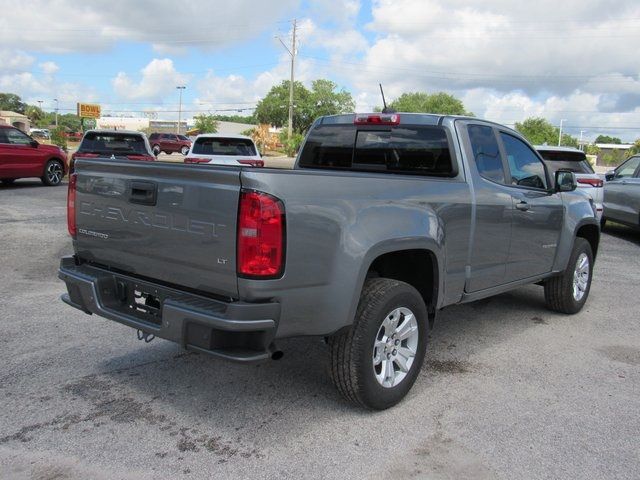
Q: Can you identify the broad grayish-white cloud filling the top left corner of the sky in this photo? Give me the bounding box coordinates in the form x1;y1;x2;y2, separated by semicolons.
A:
0;0;298;53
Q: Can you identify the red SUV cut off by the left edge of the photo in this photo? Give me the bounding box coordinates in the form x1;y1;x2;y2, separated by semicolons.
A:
0;125;67;186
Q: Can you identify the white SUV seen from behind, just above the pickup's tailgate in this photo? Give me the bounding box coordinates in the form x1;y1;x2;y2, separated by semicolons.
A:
184;133;264;167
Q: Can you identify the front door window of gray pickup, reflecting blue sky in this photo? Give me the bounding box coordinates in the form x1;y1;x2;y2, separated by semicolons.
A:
500;132;547;190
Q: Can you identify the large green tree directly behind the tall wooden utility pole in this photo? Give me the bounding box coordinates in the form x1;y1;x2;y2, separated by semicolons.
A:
254;79;355;133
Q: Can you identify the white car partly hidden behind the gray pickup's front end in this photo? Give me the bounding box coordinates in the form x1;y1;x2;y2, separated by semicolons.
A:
536;145;604;220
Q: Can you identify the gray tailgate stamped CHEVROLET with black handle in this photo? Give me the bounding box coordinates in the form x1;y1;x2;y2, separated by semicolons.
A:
75;159;240;297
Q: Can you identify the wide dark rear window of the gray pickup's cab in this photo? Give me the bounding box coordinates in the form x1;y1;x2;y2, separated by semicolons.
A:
299;124;455;176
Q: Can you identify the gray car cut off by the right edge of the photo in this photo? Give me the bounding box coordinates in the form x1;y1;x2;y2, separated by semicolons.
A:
602;155;640;228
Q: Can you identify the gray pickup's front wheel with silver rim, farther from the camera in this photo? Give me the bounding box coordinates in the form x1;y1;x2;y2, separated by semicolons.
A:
544;237;593;314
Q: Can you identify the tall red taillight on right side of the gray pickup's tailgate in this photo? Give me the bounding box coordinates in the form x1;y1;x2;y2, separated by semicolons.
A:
238;190;285;279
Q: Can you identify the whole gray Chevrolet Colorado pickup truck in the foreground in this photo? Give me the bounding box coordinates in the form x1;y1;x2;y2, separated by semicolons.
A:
59;113;600;409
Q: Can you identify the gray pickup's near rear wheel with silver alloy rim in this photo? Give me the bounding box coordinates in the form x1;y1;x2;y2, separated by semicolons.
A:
329;278;429;410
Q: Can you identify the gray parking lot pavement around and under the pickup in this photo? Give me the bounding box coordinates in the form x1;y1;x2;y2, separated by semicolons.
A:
0;180;640;479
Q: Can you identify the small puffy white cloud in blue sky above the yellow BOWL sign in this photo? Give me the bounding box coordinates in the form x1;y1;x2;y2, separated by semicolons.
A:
112;58;189;100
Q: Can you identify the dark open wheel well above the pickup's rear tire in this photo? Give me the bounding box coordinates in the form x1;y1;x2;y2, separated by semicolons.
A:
367;250;438;321
